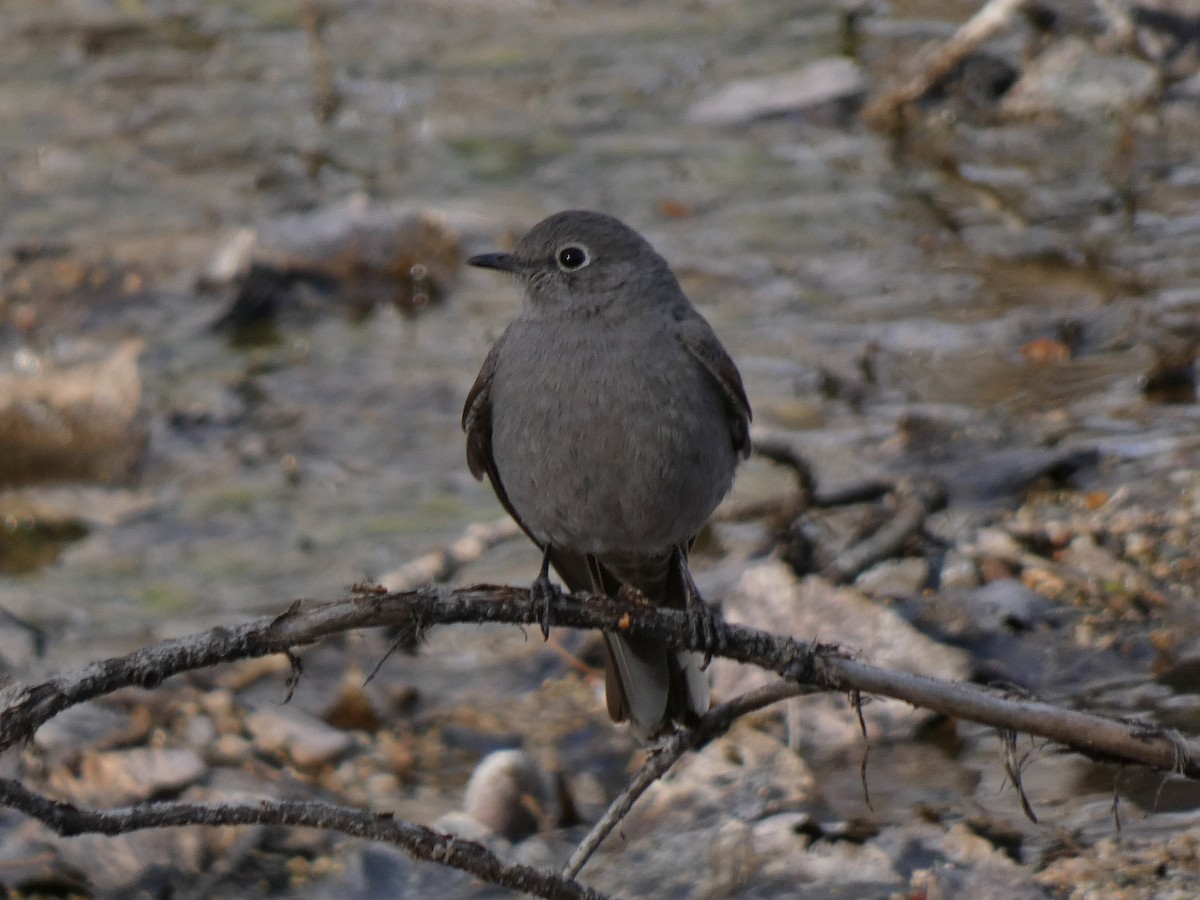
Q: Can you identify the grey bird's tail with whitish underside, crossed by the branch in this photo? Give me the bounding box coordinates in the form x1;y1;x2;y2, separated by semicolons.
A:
551;550;708;739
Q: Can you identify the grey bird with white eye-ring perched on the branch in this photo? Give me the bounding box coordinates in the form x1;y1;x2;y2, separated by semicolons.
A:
462;210;750;738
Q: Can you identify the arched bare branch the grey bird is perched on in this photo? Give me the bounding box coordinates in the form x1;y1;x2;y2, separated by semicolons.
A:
0;586;1200;778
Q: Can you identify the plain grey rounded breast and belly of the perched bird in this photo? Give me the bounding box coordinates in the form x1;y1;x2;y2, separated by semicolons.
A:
492;320;737;556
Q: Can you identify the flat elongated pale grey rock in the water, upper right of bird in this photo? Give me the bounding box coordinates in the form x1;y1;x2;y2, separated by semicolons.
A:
688;56;868;125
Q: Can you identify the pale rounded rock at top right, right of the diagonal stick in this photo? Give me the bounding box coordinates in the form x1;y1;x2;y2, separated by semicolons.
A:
1000;38;1159;118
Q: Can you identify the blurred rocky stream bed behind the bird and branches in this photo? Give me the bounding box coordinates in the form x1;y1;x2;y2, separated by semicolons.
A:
0;0;1200;896
